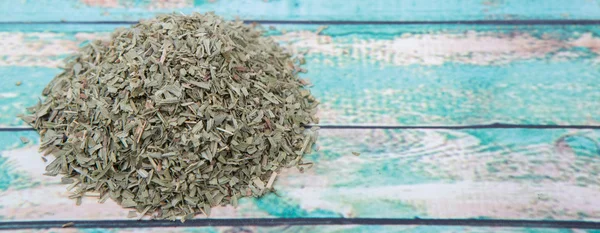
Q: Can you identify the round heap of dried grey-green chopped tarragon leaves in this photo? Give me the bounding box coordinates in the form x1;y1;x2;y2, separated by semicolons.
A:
23;13;318;220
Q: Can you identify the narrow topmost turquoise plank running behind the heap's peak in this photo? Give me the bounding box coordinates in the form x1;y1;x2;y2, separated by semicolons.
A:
0;0;600;22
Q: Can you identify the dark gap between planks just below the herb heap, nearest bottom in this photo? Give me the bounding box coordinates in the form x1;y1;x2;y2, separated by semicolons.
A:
0;218;600;230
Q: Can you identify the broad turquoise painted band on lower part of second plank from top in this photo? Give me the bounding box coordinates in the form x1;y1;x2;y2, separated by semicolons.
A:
0;58;600;126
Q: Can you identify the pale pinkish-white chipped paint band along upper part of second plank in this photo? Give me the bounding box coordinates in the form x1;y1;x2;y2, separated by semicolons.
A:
0;31;600;67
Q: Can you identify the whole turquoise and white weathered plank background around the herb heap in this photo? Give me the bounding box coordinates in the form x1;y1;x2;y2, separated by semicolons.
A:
0;0;600;232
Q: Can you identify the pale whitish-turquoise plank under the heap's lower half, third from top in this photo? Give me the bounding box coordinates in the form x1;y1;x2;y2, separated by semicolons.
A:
0;129;600;221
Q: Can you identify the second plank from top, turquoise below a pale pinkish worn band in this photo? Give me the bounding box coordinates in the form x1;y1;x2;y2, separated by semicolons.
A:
0;25;600;125
